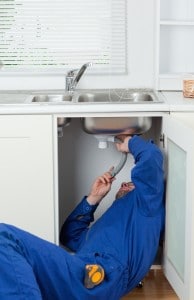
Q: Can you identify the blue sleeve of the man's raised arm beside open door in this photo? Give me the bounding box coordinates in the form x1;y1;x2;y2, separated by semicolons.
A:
128;136;164;216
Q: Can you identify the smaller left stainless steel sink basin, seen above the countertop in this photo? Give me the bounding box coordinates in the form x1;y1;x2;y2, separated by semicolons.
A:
32;94;72;104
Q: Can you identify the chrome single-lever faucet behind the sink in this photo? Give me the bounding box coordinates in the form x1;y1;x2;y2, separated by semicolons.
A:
66;62;92;92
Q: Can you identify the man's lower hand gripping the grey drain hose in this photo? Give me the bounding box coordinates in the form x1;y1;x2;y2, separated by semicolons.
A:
87;169;115;205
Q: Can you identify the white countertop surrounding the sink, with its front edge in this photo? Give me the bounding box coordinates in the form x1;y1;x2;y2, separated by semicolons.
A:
0;91;194;116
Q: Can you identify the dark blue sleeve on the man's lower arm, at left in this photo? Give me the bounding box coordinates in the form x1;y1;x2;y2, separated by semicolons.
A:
60;196;98;252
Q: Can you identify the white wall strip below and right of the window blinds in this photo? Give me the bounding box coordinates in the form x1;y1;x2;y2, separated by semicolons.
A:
0;0;156;90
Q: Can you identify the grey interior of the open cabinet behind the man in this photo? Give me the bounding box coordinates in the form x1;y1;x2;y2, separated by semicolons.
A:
58;117;162;264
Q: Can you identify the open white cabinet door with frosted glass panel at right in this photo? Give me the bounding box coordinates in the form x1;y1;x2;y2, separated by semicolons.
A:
163;113;194;300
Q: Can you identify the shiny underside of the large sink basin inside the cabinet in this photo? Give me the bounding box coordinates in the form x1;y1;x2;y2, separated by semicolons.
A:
81;116;152;135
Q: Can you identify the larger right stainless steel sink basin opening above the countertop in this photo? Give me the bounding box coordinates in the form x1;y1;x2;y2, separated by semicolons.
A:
77;89;162;104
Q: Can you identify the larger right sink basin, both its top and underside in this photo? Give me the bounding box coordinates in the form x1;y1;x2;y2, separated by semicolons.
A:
77;89;163;135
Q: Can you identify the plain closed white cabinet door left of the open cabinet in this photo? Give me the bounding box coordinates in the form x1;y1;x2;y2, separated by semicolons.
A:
0;115;55;242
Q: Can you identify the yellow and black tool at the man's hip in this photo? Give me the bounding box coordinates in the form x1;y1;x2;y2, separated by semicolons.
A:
84;265;104;289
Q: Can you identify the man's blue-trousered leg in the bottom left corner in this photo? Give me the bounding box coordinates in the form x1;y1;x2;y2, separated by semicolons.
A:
0;226;42;300
